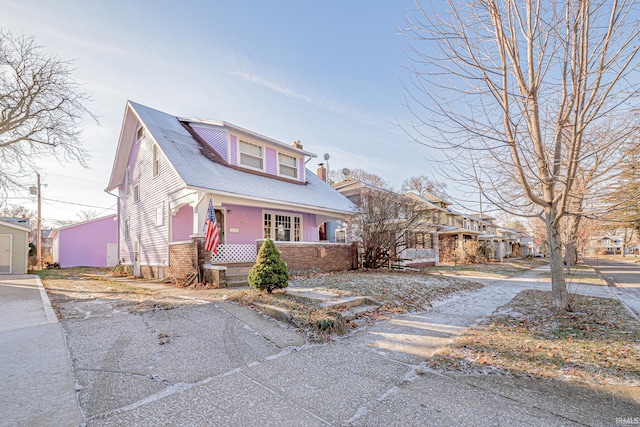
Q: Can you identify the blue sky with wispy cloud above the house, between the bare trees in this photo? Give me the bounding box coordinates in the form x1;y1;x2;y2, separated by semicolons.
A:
0;0;451;225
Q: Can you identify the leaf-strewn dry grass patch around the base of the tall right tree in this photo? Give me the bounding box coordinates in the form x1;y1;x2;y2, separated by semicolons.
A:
428;290;640;385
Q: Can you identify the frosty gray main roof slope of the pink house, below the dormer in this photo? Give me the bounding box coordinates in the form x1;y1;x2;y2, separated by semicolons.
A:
129;101;355;213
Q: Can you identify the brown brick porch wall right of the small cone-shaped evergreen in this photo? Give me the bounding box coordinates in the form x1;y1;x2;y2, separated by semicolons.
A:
257;241;358;275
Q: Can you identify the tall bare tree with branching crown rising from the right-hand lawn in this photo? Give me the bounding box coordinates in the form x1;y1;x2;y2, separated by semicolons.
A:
405;0;640;310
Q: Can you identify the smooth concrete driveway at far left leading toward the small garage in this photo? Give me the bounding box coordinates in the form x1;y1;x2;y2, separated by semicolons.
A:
0;275;82;426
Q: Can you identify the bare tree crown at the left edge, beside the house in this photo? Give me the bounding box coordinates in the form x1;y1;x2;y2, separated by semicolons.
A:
0;30;95;195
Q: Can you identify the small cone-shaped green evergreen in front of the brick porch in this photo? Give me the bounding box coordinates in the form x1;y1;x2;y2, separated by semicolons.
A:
249;239;289;293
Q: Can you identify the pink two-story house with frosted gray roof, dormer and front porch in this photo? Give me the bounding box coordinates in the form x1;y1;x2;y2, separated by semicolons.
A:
107;102;354;277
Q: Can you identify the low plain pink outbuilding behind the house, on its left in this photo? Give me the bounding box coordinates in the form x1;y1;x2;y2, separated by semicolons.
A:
50;215;118;267
